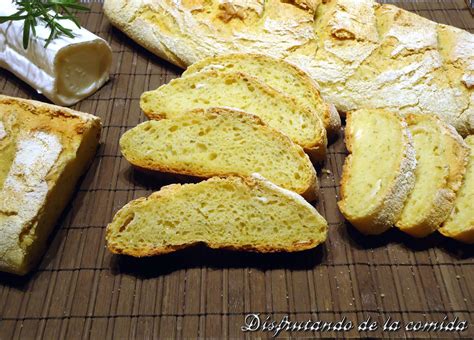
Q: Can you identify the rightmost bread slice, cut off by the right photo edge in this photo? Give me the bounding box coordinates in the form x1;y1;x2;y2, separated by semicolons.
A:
438;135;474;244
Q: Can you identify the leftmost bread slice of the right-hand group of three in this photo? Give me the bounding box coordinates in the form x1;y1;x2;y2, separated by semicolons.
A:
338;110;416;235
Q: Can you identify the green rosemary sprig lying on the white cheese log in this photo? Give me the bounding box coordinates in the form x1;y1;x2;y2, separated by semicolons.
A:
0;0;89;50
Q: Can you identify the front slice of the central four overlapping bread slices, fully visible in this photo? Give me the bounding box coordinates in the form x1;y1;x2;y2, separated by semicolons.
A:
106;176;327;257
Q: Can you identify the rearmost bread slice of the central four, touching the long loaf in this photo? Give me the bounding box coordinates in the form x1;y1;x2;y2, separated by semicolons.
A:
183;53;341;135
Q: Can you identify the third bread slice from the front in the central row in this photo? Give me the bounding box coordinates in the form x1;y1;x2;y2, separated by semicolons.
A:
140;71;327;159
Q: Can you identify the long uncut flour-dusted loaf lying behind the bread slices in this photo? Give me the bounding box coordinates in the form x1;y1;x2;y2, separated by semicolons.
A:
104;0;474;135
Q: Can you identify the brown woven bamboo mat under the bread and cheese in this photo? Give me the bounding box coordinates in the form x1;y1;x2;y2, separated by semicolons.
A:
0;0;474;339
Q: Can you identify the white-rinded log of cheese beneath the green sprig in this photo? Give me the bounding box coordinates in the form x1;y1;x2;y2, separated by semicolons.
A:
0;0;112;106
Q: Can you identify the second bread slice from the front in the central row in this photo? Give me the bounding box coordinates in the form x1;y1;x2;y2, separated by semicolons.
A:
120;108;318;200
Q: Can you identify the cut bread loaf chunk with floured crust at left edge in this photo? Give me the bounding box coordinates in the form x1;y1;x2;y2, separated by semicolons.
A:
0;96;101;275
